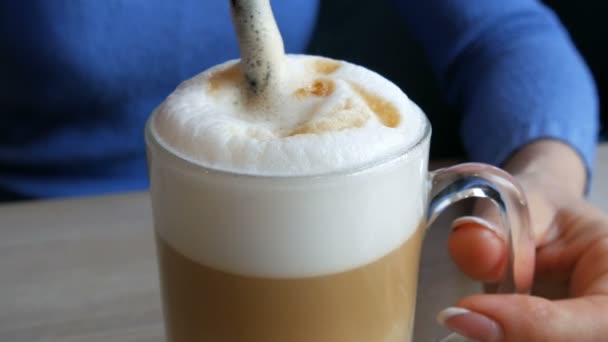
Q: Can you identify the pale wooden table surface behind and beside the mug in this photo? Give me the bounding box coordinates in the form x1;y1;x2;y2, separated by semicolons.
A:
0;145;608;342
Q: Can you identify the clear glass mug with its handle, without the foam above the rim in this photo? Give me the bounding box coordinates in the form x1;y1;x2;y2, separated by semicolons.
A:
146;115;534;342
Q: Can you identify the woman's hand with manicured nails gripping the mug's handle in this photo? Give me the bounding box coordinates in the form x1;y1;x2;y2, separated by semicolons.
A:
438;140;608;342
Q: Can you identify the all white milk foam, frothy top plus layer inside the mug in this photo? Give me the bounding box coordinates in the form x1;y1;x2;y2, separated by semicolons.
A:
149;55;428;278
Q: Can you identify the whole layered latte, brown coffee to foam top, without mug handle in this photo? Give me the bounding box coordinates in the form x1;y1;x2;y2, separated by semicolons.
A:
147;55;429;342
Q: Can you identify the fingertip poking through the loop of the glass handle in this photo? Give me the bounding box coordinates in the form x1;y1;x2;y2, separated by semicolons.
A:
448;217;507;283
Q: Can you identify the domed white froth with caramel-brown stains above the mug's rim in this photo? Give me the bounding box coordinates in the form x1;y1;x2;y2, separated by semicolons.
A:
151;55;425;176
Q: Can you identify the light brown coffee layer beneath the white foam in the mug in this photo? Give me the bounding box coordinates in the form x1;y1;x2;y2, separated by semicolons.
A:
158;227;423;342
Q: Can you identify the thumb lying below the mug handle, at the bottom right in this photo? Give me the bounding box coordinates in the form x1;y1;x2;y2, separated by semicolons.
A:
437;295;608;342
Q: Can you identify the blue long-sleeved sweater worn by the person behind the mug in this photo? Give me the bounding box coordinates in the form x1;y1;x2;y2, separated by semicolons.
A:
0;0;598;197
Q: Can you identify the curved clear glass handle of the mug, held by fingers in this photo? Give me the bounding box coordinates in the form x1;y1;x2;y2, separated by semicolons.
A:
427;163;535;341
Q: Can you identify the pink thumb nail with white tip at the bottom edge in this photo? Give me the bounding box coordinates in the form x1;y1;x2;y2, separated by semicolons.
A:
437;307;503;342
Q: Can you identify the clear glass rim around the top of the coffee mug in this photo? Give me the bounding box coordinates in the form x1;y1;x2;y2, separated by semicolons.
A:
144;110;432;180
